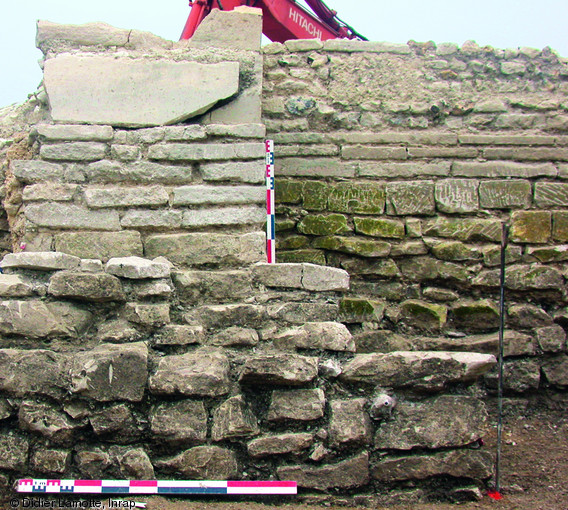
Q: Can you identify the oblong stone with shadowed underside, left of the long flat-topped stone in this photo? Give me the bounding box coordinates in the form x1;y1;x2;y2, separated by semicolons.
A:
239;353;318;386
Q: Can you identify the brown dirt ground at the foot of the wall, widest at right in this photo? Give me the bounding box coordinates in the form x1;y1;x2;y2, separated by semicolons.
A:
6;396;568;510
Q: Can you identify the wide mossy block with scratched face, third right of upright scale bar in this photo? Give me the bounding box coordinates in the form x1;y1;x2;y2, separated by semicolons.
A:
327;183;385;214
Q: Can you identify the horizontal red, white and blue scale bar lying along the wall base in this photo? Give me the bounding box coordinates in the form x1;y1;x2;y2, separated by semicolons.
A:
17;478;298;495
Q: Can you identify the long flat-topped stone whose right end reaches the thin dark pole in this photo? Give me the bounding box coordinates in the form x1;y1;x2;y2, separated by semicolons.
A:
340;351;496;390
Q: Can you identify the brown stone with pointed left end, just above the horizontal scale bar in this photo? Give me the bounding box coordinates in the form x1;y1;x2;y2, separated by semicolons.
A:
154;446;238;480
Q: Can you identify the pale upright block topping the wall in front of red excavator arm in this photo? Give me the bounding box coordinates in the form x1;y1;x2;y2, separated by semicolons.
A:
188;6;262;51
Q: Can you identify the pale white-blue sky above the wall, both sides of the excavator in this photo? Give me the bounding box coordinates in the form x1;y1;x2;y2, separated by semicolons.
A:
0;0;568;107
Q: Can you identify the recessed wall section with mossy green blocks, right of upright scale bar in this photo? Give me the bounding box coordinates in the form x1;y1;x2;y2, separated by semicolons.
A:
263;41;568;396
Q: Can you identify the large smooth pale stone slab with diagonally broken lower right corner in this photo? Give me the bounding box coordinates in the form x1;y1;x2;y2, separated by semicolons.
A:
44;55;239;127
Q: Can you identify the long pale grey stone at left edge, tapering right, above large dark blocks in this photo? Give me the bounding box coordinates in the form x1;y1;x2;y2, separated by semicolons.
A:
0;301;91;338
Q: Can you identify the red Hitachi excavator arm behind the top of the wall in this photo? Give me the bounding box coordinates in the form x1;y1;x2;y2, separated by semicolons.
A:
181;0;367;42
